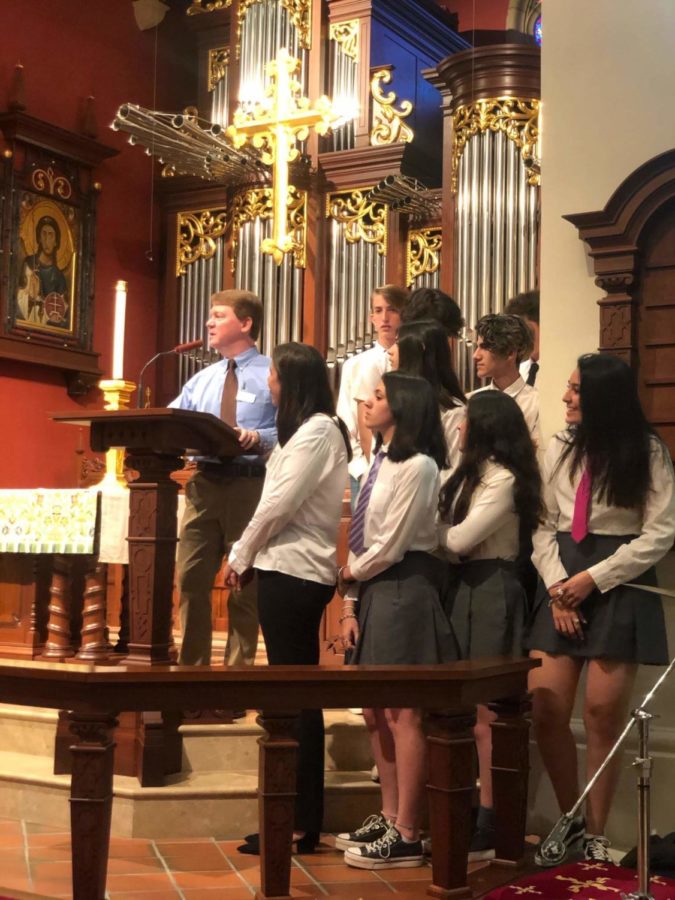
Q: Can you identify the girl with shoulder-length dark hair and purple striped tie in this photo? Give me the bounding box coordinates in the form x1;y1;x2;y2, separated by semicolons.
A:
336;372;457;869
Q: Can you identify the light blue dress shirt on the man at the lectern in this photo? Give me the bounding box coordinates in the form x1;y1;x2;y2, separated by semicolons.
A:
169;347;277;465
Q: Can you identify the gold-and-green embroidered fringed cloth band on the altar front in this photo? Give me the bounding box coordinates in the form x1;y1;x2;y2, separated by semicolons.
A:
0;489;99;554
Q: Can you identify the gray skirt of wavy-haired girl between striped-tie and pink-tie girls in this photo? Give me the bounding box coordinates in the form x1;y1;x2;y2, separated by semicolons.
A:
445;559;526;659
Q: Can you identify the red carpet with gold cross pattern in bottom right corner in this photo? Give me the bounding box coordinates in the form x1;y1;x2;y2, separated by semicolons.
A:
485;862;675;900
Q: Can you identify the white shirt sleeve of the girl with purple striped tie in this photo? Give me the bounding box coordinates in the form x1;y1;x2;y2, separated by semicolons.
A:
349;453;439;581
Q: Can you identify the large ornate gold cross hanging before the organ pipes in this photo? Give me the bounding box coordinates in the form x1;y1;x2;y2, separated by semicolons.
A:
227;49;344;265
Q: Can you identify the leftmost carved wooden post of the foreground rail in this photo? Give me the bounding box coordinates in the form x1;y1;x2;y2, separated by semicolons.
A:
70;713;117;900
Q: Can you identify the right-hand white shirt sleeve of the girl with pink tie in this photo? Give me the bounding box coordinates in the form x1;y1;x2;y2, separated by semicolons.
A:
588;443;675;594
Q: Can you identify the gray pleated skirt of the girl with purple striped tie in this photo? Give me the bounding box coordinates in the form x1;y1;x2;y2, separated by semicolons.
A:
350;551;458;665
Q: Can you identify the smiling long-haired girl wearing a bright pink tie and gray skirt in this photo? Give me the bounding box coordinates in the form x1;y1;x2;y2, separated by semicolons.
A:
527;353;675;866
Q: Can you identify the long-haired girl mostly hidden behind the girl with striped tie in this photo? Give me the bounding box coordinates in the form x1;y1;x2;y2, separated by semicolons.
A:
389;319;466;472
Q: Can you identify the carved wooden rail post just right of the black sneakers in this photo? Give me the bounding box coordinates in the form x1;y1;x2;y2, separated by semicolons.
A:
427;713;476;898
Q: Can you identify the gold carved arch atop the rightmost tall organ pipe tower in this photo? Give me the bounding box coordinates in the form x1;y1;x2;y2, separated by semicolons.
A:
451;97;541;193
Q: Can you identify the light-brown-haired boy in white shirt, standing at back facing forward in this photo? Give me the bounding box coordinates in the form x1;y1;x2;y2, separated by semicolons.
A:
337;284;409;509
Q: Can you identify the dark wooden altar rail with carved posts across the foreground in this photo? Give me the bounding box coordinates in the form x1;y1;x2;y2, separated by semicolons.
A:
0;658;537;900
